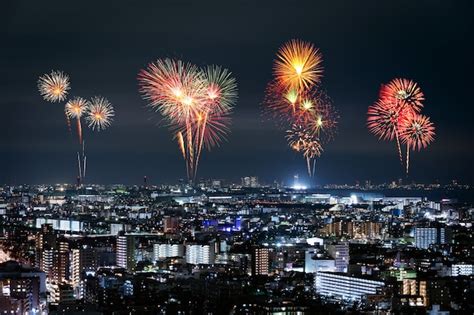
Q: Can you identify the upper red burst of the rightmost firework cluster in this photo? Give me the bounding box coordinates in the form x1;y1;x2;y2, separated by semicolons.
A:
380;79;425;113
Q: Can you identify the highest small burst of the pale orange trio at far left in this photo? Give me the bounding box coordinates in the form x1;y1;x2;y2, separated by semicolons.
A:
38;71;70;102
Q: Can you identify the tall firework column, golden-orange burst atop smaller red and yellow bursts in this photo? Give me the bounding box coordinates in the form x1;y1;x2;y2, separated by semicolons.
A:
263;40;338;177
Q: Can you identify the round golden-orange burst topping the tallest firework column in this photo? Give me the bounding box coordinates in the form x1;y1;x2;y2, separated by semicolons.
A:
274;39;323;91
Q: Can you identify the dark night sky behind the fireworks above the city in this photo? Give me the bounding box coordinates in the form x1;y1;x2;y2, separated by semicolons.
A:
0;0;474;184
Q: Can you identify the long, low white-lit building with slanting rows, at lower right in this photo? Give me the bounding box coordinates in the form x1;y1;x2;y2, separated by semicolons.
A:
315;272;385;301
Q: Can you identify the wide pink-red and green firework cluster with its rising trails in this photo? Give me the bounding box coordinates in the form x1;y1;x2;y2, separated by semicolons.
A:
138;59;237;181
